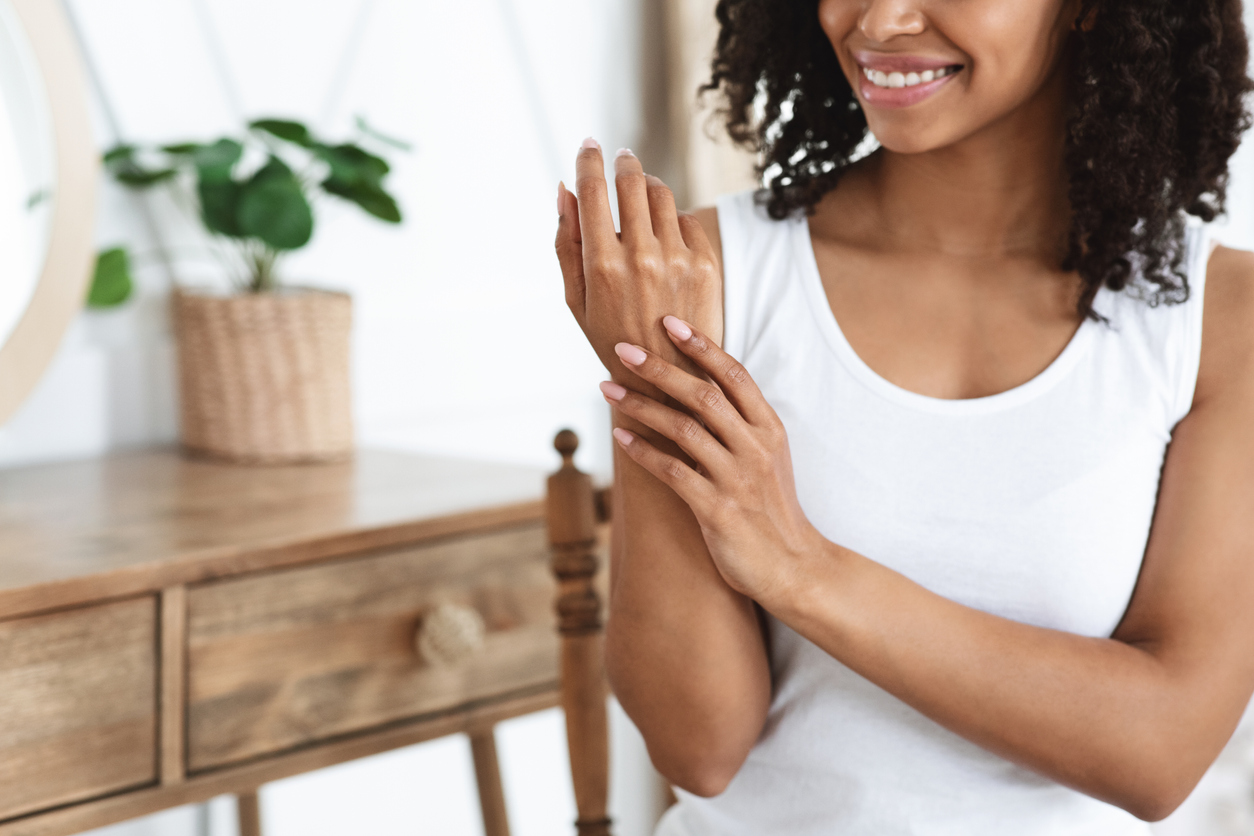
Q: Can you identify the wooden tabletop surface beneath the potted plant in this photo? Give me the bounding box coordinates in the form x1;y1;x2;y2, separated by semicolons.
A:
0;450;544;618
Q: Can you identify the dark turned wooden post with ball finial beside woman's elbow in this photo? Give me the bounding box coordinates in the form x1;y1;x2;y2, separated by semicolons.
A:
547;430;611;836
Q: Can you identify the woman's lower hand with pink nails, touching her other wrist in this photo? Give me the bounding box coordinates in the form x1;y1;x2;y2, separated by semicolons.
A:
601;316;825;605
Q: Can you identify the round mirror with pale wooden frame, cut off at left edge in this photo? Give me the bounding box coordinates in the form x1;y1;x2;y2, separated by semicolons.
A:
0;0;98;421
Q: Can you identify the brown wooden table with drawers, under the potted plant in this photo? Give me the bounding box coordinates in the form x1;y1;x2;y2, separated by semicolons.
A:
0;451;581;836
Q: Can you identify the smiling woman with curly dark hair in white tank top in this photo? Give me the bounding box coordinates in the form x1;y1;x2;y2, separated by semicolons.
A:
557;0;1254;836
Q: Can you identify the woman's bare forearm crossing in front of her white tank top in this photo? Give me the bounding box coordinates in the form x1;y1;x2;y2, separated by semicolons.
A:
761;541;1231;818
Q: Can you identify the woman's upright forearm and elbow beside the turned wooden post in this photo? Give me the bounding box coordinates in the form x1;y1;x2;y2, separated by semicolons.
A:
606;431;770;796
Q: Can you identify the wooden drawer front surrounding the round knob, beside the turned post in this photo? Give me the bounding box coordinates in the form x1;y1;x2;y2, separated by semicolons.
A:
187;523;558;771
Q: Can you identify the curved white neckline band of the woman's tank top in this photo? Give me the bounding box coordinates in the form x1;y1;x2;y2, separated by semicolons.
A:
794;217;1097;415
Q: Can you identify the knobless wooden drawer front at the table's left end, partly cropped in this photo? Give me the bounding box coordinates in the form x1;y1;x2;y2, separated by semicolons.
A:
0;598;157;820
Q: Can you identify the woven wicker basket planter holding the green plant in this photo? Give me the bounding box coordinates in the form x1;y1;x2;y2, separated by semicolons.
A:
173;288;352;464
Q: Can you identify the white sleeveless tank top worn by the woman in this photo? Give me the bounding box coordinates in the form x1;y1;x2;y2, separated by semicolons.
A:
657;192;1209;836
